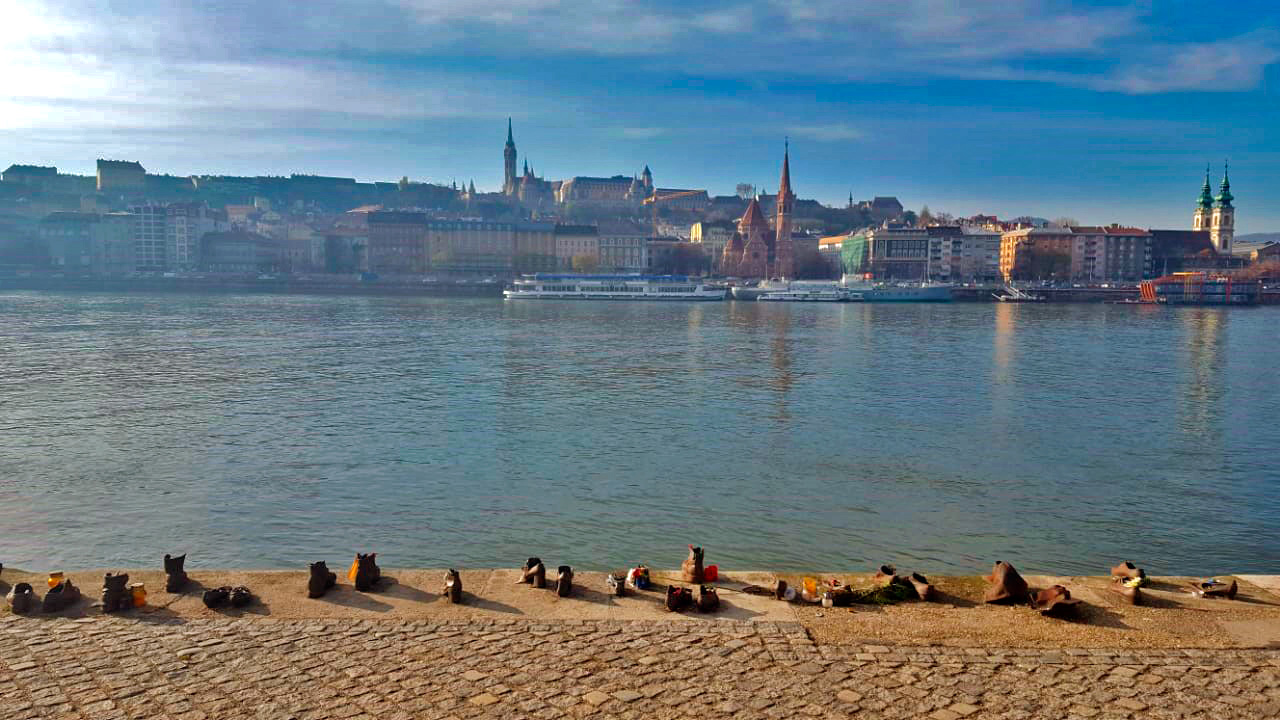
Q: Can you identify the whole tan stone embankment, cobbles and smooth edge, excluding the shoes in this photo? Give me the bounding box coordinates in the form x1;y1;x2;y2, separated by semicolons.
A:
0;568;1280;720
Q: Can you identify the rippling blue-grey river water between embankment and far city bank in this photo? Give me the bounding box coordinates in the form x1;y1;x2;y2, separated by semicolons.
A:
0;292;1280;574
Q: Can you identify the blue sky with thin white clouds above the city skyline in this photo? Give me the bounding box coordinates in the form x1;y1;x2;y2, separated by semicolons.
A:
0;0;1280;233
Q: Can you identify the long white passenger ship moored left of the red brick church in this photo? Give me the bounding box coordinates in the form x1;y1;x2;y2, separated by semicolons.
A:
502;273;724;300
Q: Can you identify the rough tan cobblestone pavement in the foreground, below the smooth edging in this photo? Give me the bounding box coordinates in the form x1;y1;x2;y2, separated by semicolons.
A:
0;616;1280;720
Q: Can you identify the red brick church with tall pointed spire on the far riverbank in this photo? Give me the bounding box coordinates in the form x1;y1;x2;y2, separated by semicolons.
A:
721;146;796;278
